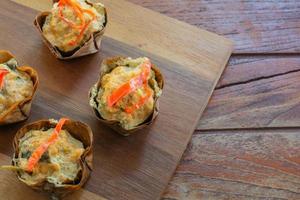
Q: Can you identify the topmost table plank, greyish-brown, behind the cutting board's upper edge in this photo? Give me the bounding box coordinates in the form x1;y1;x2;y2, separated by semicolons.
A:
130;0;300;53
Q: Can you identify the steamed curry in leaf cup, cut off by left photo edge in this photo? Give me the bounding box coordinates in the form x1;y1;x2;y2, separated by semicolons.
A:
0;50;39;125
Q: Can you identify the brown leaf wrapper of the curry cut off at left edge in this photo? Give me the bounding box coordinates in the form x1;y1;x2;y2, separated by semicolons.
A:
0;50;39;125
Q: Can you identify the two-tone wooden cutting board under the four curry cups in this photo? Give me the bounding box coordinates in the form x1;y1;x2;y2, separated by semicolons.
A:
0;0;233;200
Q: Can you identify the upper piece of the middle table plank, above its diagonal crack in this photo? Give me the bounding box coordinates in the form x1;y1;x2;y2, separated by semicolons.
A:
216;55;300;89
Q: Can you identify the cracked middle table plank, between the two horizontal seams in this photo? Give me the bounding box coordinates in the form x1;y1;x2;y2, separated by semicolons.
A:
198;56;300;129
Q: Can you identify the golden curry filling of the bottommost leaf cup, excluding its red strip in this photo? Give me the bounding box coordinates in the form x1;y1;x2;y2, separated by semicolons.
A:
15;122;84;185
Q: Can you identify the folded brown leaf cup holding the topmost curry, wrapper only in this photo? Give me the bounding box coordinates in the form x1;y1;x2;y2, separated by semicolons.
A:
34;0;107;60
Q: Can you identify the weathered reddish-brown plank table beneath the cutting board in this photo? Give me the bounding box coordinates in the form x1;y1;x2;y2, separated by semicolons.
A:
126;0;300;200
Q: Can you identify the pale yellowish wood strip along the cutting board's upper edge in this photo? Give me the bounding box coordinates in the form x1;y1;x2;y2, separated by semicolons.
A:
12;0;233;79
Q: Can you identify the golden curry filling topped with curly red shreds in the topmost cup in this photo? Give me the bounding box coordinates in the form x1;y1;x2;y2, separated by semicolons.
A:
43;0;106;52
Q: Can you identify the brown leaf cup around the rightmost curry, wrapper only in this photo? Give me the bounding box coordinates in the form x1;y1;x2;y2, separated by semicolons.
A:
89;57;164;136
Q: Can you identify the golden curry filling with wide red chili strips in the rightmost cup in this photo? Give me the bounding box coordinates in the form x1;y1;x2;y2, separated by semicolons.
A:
96;57;161;130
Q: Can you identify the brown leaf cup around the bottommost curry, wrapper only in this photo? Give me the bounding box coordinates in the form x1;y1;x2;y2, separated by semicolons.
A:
12;120;93;199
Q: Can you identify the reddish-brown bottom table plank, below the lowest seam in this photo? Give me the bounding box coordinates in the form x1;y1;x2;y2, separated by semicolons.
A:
163;129;300;200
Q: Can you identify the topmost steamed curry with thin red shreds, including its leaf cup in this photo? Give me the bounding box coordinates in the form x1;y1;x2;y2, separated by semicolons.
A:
34;0;107;60
